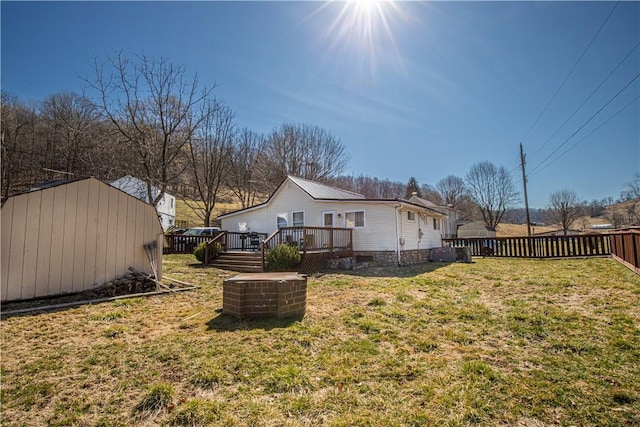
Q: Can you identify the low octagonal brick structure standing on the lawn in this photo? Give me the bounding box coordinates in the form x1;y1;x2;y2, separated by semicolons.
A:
222;273;307;319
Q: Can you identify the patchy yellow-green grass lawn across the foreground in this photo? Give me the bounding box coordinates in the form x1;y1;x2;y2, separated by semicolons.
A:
1;255;640;426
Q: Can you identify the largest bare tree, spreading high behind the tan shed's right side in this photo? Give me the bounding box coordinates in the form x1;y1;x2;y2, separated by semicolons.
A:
86;52;213;210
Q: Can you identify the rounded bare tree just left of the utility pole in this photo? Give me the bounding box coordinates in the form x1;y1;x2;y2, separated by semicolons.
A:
465;161;518;227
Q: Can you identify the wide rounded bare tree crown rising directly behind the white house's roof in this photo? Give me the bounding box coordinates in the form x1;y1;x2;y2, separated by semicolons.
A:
264;124;349;185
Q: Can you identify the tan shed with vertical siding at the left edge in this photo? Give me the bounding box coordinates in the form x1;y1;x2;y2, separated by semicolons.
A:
0;178;163;302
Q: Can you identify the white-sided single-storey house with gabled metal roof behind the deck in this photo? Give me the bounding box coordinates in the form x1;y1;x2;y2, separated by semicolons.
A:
218;176;446;265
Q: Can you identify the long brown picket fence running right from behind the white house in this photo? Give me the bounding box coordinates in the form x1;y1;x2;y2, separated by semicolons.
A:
442;234;611;258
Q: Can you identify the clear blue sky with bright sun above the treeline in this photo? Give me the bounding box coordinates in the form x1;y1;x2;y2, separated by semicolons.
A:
1;1;640;207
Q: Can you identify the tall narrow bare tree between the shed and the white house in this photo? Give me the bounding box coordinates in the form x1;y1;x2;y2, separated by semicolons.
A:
184;100;235;227
